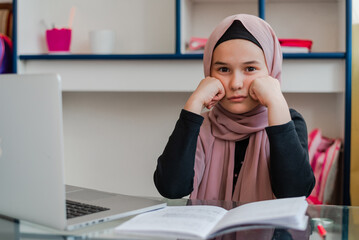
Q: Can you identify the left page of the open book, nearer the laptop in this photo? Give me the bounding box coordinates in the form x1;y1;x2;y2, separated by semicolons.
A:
116;205;227;238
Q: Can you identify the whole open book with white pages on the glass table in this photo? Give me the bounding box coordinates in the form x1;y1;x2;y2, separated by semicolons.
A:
116;197;308;239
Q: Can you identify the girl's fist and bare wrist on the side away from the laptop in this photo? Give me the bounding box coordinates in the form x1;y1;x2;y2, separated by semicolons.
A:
249;76;291;126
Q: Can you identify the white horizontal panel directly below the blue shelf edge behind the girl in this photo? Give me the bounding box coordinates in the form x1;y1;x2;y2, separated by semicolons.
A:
18;59;345;93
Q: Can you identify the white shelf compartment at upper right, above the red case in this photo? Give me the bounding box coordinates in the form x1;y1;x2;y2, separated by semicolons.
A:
266;0;345;52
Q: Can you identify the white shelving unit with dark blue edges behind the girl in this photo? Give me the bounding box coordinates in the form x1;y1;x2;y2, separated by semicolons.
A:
14;0;351;204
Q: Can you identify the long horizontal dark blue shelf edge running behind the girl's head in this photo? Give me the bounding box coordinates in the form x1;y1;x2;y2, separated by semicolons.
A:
19;52;346;60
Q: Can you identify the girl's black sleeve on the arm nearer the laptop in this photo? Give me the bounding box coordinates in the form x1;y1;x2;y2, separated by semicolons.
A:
153;109;204;199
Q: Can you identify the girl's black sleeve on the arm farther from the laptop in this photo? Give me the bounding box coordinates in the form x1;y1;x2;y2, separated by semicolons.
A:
266;109;315;198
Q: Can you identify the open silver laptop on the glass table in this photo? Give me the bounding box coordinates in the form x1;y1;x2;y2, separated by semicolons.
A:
0;74;166;230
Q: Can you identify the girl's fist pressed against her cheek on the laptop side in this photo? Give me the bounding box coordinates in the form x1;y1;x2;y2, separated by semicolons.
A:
184;77;225;114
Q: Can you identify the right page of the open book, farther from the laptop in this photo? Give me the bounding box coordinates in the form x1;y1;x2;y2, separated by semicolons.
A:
212;197;308;233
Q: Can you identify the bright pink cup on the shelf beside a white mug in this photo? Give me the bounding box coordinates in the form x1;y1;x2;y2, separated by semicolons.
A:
46;28;71;52
